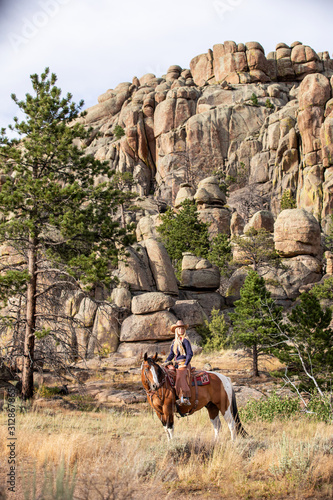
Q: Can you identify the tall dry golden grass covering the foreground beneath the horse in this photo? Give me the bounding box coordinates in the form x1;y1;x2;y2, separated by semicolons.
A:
0;405;333;500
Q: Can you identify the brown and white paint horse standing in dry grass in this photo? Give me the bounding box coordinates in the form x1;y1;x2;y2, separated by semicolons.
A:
141;353;247;440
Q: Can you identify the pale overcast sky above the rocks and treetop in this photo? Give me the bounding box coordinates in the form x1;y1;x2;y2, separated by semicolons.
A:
0;0;333;127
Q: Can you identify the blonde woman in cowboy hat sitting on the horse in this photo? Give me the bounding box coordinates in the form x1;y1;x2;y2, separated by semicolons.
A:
165;320;193;406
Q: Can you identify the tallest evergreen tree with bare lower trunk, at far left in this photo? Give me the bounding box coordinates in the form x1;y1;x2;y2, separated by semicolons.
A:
0;68;132;398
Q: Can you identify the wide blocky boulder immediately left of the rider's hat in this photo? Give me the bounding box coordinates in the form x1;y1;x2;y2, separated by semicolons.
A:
120;311;177;342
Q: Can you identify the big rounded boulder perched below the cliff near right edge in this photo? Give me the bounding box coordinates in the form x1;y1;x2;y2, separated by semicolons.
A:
274;208;321;257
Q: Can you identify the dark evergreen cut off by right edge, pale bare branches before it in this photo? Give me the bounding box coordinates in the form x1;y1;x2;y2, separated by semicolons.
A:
275;293;333;390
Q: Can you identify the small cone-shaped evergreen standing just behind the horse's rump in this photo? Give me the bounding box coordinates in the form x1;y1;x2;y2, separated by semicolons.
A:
230;269;281;377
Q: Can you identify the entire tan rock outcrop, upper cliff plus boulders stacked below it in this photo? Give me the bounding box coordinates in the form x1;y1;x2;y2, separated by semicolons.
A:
5;41;333;364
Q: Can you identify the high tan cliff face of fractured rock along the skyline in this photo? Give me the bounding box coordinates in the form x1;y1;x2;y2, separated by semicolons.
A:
80;42;333;228
